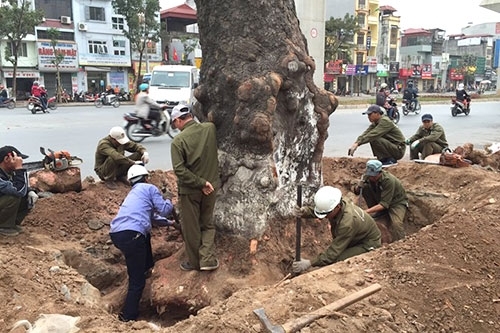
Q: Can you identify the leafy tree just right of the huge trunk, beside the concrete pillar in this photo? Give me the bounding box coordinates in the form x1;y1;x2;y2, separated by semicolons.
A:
325;14;359;63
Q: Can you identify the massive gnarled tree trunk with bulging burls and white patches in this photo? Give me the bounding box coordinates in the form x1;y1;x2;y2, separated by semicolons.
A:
195;0;337;238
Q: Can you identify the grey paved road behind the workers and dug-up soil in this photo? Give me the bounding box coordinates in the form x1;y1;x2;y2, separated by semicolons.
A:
0;102;500;176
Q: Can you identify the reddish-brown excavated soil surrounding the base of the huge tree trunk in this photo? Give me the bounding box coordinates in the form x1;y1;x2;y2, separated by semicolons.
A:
0;158;500;333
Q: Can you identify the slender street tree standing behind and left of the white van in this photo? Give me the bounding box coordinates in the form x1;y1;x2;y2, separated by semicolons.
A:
111;0;160;87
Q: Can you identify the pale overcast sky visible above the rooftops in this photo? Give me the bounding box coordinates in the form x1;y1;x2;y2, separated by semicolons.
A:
160;0;500;35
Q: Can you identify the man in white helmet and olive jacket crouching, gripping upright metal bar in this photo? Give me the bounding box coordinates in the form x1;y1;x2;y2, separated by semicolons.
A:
292;186;381;273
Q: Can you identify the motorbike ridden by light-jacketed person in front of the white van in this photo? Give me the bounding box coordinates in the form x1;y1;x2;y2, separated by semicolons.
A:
123;105;180;142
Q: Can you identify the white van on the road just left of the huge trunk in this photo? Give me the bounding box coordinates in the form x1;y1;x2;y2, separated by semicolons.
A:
149;65;199;108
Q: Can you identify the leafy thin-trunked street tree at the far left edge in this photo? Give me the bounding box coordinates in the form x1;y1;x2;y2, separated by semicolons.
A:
0;0;44;97
